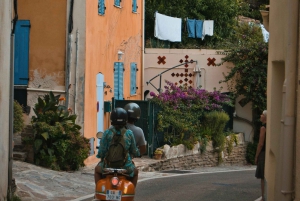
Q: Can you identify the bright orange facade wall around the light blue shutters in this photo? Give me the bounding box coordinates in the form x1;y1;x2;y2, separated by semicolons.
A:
84;0;143;151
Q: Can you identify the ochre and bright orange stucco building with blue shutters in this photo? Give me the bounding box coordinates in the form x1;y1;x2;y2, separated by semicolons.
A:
14;0;144;163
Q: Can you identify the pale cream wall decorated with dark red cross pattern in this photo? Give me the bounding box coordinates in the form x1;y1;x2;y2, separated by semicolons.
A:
144;48;232;97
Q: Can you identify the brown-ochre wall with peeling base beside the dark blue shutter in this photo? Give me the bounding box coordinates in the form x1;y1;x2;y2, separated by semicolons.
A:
18;0;67;88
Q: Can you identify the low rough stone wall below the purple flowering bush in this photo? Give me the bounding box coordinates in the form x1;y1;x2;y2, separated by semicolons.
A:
142;133;247;171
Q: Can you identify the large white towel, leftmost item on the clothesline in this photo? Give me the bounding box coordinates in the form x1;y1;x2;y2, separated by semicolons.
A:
154;12;182;42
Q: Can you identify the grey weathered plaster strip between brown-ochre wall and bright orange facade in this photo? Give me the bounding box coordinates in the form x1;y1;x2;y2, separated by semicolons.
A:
65;0;89;131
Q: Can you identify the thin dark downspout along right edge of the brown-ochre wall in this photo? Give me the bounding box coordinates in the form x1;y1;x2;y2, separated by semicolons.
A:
65;0;74;108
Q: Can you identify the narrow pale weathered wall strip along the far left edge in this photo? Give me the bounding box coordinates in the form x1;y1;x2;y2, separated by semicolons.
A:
0;1;12;201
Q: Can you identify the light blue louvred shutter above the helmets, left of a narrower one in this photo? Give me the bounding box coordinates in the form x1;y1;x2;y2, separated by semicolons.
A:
114;62;124;100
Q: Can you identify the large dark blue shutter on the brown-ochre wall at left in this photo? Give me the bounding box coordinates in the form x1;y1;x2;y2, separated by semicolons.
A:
14;20;30;85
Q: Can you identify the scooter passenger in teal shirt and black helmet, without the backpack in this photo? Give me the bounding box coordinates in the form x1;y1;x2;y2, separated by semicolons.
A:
94;108;140;186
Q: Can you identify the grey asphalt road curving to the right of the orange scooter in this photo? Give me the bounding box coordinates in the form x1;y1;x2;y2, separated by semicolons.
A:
135;170;260;201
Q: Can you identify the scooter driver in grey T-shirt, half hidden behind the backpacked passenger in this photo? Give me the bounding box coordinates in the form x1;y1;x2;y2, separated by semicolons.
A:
124;103;147;156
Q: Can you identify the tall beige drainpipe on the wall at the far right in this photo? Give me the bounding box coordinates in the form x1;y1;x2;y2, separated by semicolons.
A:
280;0;299;201
